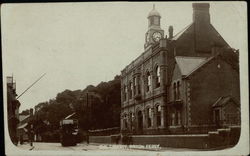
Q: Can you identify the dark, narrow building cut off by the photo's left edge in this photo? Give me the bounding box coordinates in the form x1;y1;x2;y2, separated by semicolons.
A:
7;76;21;144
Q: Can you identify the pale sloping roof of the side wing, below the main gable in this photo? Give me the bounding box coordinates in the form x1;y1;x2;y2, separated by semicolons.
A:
175;56;207;76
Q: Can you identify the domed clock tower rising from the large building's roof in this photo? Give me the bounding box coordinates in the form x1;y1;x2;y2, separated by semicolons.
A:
144;5;164;49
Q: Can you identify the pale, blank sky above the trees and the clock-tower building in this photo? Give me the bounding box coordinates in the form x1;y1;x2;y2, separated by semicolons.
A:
1;2;247;111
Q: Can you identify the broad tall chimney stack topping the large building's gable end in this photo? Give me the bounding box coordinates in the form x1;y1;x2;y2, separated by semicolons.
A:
192;3;210;24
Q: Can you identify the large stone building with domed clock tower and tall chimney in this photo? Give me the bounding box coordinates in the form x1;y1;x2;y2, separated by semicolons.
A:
121;3;240;134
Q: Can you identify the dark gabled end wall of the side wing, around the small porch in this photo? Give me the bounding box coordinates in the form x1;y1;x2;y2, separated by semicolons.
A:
189;58;240;125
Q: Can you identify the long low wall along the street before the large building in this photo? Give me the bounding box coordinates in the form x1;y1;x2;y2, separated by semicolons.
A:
89;127;240;149
